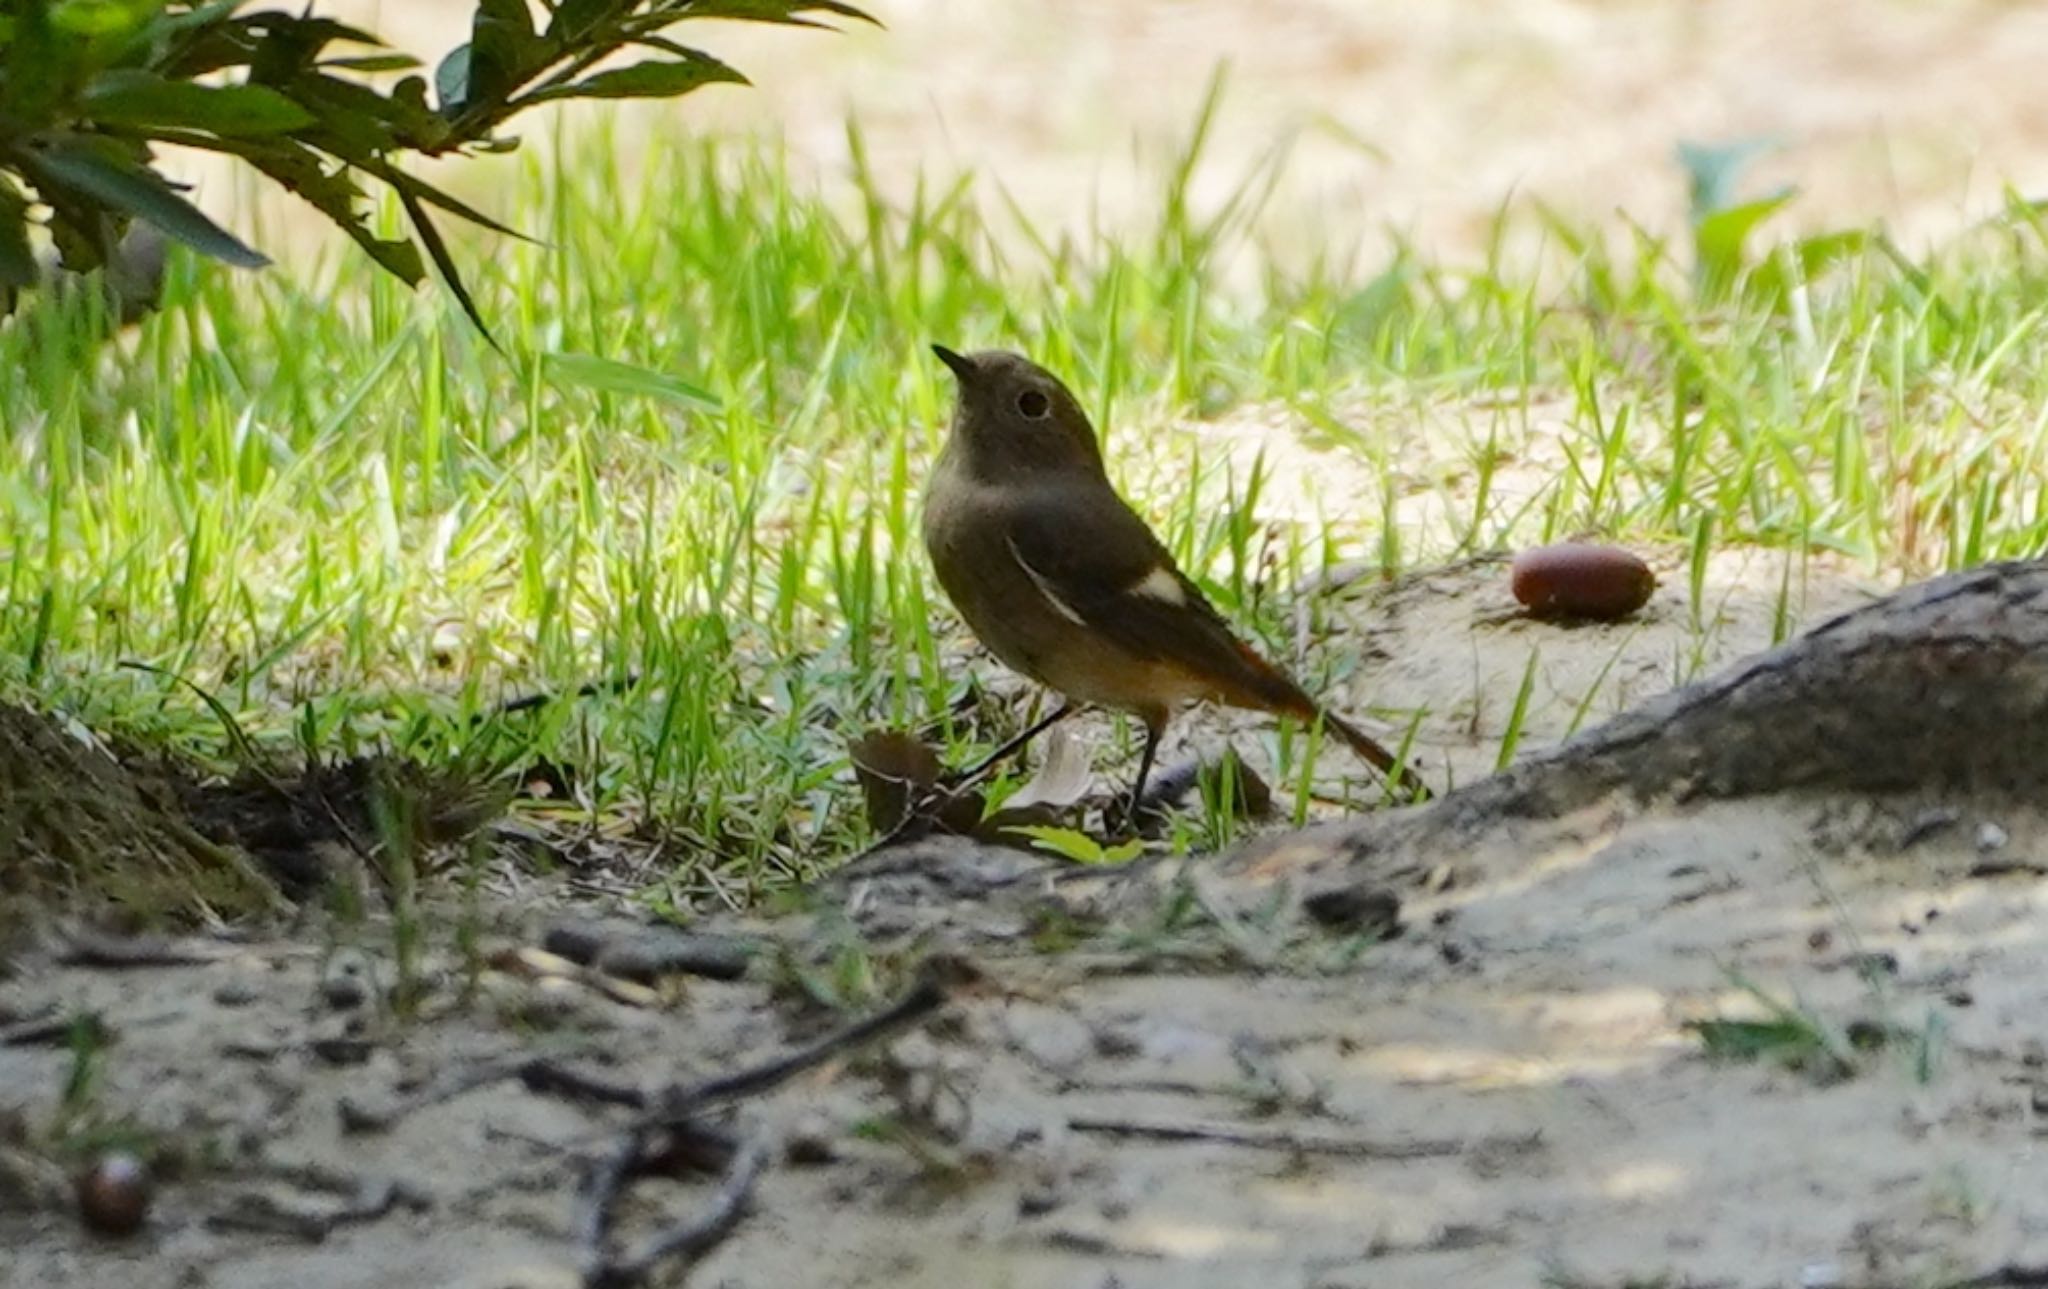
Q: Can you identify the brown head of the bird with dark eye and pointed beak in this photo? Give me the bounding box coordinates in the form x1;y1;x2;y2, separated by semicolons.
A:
932;344;1102;477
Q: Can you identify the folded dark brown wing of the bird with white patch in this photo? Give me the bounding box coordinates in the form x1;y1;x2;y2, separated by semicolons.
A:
1004;486;1309;711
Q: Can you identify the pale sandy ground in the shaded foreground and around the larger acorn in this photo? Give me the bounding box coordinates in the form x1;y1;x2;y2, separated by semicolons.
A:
16;555;2048;1289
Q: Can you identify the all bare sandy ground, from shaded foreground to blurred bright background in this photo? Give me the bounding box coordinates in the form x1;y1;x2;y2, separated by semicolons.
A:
0;0;2048;1289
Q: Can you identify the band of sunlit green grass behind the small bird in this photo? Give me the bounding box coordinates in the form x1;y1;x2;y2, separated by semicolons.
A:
0;97;2048;891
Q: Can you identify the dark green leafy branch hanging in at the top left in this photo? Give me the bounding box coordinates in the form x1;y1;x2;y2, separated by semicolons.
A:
0;0;870;330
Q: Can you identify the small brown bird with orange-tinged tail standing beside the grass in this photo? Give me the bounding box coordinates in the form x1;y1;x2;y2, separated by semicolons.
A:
924;344;1423;809
